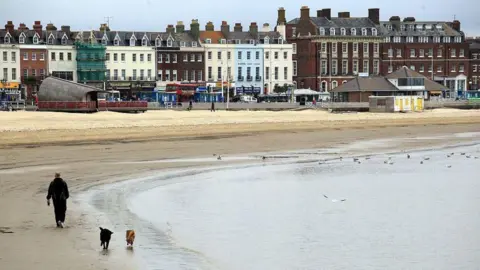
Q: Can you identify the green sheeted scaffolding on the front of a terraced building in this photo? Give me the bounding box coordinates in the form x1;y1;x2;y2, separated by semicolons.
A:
75;42;106;82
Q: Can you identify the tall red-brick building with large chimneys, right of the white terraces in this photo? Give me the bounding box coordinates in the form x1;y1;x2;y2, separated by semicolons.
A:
286;6;383;92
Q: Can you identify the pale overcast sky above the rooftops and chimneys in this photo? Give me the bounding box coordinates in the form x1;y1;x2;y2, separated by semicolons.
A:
0;0;480;36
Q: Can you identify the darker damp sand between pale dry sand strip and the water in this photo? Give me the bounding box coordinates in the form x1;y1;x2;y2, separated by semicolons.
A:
0;113;480;270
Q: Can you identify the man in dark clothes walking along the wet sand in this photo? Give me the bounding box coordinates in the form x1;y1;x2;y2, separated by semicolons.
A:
47;173;70;228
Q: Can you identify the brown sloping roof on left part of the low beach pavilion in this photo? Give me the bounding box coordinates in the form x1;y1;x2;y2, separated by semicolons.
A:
331;77;398;92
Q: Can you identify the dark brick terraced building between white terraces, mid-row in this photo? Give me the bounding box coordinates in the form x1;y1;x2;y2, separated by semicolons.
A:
154;20;205;88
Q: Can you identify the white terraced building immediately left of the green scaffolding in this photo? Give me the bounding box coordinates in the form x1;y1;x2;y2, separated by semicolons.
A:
46;23;77;82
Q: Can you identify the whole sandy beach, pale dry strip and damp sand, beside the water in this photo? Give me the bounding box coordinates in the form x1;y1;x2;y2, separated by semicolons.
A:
0;109;480;270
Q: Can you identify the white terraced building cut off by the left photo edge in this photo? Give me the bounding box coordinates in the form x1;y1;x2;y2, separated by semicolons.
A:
0;21;20;100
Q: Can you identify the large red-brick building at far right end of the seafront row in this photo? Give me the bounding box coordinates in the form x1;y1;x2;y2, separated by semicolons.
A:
381;16;469;97
